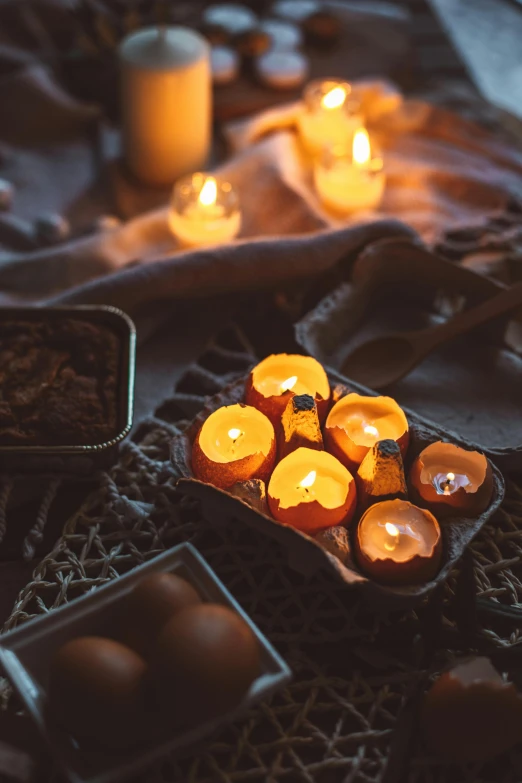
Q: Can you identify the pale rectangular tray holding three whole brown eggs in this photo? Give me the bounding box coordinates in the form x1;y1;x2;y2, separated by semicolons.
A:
0;544;291;783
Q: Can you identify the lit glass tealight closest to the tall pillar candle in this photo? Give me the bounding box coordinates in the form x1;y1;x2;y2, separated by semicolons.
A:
169;173;241;248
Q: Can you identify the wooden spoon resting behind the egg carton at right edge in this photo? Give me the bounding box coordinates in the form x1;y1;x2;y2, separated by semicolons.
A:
342;282;522;389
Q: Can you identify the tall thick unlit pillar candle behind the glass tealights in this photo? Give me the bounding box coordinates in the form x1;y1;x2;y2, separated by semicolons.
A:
120;27;212;185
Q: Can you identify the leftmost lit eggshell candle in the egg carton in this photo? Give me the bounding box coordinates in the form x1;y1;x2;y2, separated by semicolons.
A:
192;404;276;489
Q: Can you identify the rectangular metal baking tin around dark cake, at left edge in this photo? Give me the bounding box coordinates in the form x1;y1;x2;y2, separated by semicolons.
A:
0;305;136;477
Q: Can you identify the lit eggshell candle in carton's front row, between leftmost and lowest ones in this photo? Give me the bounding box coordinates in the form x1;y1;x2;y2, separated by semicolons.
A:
268;448;357;535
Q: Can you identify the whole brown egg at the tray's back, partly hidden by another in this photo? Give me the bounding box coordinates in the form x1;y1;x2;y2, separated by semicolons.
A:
119;573;201;657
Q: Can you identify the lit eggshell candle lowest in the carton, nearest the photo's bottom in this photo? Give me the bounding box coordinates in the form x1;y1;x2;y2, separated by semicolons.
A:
355;500;442;585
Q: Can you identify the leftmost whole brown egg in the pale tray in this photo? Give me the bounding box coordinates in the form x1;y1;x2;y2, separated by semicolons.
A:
49;636;147;748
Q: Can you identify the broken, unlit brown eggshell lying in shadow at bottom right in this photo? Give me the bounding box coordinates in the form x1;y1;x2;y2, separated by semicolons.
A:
421;658;522;763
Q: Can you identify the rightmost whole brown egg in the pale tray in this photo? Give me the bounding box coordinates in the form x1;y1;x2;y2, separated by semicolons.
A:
150;604;261;723
